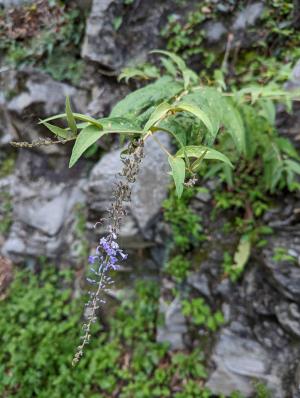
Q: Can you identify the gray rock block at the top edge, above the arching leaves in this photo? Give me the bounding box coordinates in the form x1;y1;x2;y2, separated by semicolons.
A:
82;0;171;69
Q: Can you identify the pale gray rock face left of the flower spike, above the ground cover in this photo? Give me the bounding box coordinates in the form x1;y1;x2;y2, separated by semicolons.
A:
2;151;84;262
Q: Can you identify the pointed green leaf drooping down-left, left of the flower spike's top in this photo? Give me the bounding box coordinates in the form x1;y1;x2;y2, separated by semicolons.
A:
69;126;107;167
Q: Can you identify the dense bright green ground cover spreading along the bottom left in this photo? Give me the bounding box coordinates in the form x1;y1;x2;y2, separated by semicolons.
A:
0;261;229;398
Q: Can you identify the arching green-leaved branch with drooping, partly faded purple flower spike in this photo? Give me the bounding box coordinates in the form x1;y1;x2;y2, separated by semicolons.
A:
14;51;300;364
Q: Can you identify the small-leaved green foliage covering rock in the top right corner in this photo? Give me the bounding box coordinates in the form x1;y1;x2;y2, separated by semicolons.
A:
161;0;300;87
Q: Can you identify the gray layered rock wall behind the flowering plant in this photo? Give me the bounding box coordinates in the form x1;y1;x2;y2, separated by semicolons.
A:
0;0;300;398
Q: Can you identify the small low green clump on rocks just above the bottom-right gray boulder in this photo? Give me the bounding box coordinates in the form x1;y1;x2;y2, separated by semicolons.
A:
182;298;225;332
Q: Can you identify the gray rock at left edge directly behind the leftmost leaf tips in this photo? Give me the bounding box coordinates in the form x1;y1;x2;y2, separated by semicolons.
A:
0;68;87;154
